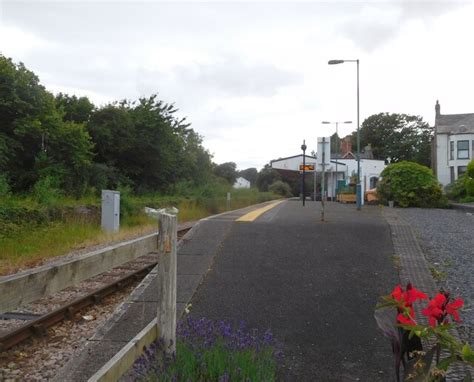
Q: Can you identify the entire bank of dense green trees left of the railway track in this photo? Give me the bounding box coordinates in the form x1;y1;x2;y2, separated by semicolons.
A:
0;55;213;195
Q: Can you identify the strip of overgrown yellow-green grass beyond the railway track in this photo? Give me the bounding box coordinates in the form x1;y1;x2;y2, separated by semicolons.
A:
0;189;276;275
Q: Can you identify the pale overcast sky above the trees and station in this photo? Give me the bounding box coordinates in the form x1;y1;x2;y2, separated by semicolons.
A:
0;0;474;169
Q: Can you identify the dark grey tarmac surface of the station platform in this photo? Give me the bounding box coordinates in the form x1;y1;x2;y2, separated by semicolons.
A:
191;200;397;381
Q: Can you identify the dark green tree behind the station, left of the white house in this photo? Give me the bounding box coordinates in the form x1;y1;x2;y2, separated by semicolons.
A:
351;113;433;167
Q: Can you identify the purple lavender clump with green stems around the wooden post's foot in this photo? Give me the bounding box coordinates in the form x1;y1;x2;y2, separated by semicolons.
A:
134;317;281;382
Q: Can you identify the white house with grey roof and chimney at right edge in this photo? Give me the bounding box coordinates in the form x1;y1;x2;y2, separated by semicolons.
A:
432;101;474;186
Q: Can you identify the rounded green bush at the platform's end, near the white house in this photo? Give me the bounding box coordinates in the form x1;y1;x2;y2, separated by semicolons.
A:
377;161;447;207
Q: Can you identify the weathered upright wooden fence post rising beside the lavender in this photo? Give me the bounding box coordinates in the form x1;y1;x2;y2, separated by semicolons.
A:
156;212;178;353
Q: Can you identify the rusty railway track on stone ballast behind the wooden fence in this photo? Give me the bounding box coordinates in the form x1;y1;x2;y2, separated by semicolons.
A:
0;227;191;381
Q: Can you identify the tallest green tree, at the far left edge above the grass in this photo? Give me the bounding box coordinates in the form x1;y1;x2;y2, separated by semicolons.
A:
0;55;92;191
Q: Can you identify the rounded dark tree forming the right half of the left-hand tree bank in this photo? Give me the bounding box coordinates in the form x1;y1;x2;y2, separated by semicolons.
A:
88;95;212;193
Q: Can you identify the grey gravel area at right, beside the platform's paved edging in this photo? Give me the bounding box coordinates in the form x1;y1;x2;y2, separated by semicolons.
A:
396;208;474;344
